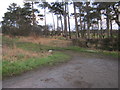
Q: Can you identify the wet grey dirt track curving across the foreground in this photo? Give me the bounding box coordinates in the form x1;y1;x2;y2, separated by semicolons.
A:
3;52;118;88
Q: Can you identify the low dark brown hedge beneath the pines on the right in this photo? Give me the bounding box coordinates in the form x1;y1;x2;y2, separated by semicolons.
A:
72;38;120;51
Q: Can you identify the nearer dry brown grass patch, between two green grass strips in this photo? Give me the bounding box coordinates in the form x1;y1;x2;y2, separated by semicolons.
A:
2;46;51;61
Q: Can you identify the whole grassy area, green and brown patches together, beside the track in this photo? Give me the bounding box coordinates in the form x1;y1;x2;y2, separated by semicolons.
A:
2;36;118;77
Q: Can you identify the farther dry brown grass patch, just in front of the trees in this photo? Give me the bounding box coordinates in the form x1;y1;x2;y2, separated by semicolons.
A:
19;36;71;47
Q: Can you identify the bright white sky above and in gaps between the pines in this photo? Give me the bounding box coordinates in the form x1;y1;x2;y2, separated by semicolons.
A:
0;0;118;29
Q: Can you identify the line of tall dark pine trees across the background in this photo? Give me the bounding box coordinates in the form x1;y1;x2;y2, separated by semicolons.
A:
2;1;120;39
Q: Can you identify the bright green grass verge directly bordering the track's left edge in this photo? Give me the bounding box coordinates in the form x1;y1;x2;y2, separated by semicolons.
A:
2;52;70;77
